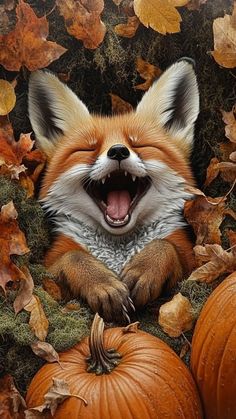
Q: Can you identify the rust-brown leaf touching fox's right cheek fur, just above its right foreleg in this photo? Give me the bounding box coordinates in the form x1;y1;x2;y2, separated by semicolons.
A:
184;196;228;244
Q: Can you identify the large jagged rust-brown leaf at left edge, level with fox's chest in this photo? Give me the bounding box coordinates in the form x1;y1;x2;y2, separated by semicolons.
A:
0;201;29;292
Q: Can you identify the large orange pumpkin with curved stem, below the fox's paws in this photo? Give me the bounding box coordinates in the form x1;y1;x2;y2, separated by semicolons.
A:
26;314;202;419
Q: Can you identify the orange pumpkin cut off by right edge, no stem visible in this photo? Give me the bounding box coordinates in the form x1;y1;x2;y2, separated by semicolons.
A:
191;272;236;419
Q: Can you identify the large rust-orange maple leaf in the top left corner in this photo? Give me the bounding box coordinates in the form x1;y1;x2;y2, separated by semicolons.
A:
0;0;66;71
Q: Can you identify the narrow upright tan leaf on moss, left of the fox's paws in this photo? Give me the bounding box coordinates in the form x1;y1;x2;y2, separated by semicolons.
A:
13;266;34;314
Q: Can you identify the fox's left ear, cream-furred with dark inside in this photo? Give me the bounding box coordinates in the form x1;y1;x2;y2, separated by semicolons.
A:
29;71;90;156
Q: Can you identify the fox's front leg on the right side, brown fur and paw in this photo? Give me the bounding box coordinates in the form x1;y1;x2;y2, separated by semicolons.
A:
121;230;195;307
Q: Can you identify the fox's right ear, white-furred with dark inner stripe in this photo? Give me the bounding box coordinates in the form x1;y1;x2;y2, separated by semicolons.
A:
136;58;199;146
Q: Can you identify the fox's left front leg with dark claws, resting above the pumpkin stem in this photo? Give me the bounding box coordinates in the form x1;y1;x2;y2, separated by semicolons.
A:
45;236;132;321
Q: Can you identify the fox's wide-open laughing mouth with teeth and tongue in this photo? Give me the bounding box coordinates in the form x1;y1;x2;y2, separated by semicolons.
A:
84;170;151;227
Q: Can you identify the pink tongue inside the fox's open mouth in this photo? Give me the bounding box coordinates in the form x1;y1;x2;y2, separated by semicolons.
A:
106;190;131;220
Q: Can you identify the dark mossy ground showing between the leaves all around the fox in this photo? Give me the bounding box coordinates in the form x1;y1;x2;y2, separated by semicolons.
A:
0;0;236;392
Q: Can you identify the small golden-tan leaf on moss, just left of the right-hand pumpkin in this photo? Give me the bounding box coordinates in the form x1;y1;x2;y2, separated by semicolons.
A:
158;292;194;337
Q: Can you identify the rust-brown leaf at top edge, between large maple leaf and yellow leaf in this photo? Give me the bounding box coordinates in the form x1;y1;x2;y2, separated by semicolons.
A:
56;0;106;49
